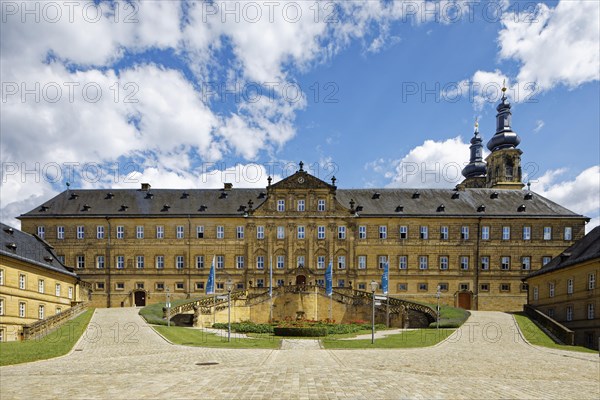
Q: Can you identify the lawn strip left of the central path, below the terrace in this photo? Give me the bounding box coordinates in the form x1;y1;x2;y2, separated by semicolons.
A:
153;326;281;349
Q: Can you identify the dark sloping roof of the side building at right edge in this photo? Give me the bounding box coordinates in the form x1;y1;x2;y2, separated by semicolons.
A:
526;226;600;279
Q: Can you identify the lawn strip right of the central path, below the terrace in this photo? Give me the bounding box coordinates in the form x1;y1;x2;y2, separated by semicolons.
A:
322;329;454;349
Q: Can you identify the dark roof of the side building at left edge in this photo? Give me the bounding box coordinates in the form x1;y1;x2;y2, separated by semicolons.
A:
0;223;77;277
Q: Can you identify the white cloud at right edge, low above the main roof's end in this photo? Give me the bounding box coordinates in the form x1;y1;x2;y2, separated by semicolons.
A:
531;165;600;231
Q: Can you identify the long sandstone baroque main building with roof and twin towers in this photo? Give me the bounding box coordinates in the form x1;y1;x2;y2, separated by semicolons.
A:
20;97;587;310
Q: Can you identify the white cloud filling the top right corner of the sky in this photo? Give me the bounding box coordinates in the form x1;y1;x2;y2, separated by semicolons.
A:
498;0;600;90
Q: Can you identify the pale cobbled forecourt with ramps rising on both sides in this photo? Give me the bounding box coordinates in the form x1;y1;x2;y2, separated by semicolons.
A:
0;308;600;400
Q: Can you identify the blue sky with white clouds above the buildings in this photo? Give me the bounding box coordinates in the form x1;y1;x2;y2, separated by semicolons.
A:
0;0;600;230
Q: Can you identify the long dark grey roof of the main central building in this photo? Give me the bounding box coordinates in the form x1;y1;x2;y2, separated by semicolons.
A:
20;184;585;219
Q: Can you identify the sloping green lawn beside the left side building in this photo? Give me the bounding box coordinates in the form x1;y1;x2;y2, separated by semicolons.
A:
0;309;94;365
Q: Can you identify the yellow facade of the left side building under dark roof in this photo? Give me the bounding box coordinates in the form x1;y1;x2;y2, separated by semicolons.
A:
0;255;81;341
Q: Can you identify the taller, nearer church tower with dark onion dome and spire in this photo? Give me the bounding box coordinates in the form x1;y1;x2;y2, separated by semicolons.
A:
485;87;523;189
